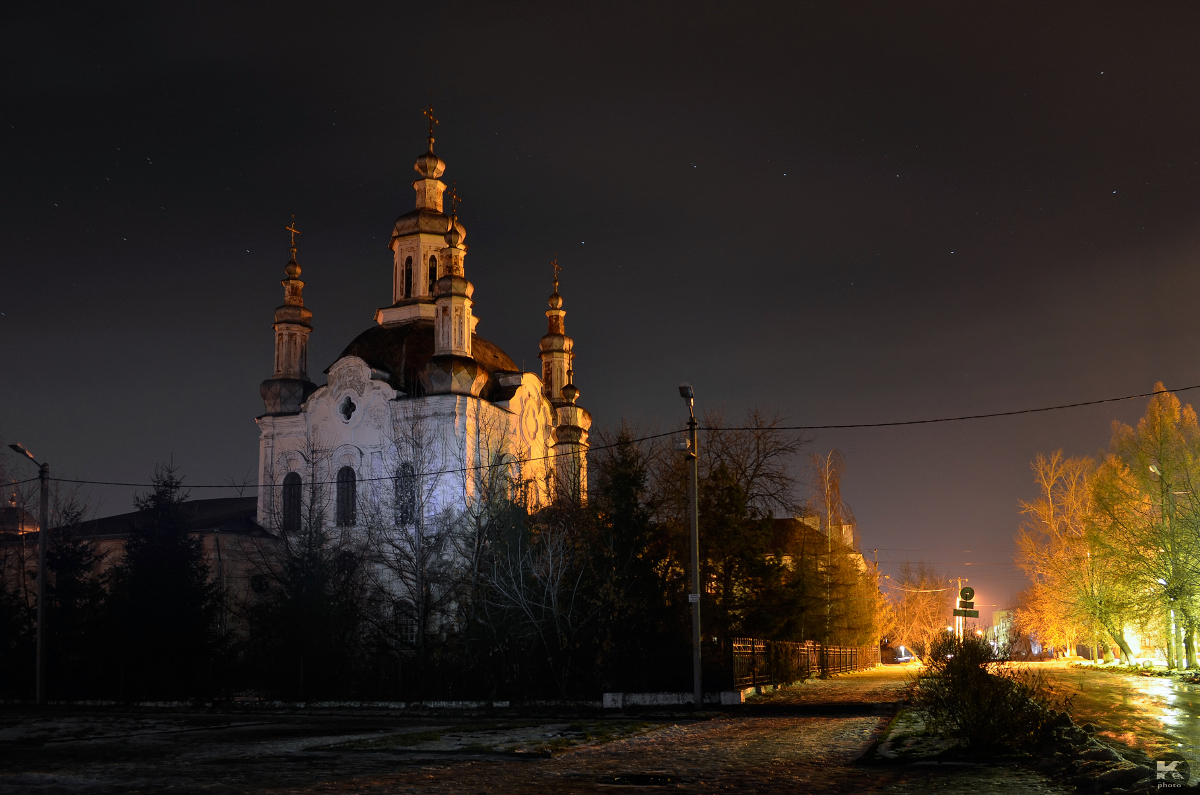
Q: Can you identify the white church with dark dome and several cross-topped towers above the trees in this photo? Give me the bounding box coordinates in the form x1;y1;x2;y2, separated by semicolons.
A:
257;108;592;532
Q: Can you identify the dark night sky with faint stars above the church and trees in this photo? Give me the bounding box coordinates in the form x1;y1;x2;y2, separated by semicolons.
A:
0;2;1200;617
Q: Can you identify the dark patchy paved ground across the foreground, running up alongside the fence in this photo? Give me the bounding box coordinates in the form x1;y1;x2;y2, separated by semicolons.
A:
0;667;1063;795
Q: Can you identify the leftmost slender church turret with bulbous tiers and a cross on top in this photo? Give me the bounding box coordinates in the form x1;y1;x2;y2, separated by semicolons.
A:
258;216;317;414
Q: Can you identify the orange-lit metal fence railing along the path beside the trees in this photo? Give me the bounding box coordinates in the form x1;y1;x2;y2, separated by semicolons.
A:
731;638;880;688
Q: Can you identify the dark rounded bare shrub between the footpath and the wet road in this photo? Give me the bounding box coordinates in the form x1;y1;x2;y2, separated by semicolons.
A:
916;634;1070;751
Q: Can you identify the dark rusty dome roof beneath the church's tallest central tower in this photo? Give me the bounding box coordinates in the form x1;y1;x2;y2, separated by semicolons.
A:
325;321;521;400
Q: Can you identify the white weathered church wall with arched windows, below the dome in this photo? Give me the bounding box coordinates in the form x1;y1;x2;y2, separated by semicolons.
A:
258;357;556;531
